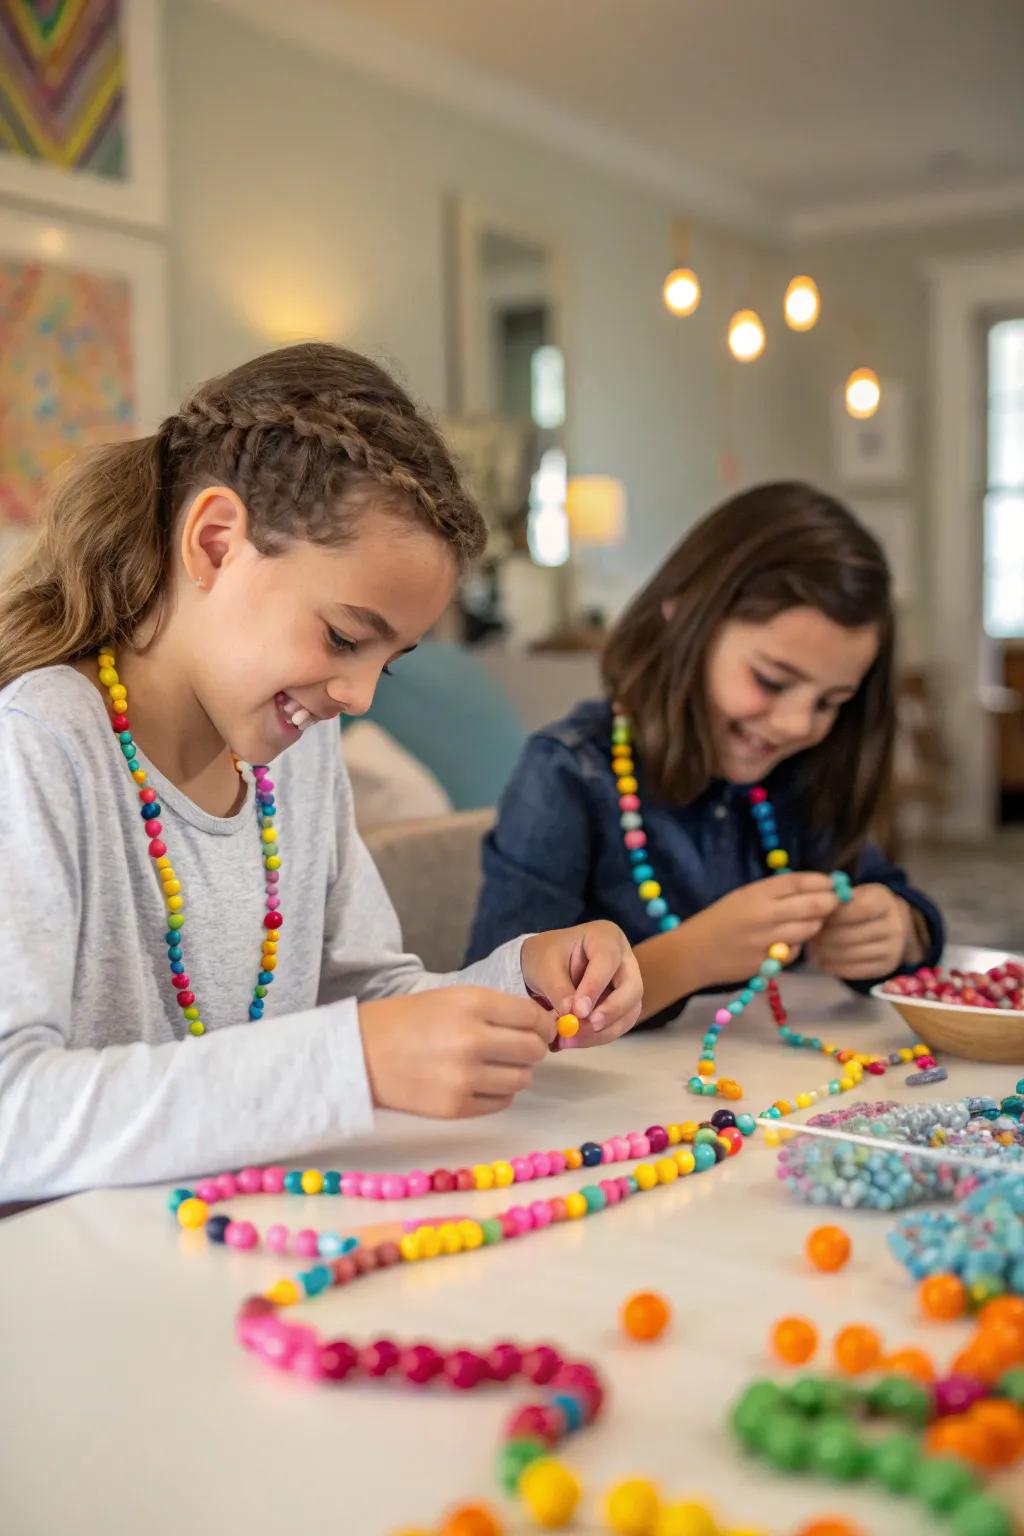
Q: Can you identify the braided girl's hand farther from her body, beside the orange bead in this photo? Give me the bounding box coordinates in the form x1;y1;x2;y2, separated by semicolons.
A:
522;922;643;1049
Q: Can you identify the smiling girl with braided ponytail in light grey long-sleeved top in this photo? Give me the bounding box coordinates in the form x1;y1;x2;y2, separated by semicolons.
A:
0;344;640;1200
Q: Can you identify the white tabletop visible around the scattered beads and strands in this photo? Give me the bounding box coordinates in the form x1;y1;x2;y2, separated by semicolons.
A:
0;946;1024;1536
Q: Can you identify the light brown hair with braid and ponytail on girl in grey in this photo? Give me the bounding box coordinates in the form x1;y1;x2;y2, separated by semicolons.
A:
0;343;485;687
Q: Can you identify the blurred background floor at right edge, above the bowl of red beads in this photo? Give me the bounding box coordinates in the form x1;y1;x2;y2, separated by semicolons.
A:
901;826;1024;954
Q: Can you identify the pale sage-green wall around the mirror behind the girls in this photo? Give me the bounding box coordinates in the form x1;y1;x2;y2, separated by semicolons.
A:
167;0;821;602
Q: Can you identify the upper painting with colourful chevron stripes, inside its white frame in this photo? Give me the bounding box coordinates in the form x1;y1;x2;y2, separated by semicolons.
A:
0;0;126;180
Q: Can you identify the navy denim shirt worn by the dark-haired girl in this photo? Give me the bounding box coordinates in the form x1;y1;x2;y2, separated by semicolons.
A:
467;700;944;1025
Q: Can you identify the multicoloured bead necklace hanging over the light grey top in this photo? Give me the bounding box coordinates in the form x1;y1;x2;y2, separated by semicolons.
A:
98;645;284;1035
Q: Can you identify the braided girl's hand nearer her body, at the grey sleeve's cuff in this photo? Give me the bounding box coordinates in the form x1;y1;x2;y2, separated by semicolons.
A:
359;986;554;1120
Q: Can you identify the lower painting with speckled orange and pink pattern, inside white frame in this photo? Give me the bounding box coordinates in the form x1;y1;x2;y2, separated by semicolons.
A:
0;258;137;528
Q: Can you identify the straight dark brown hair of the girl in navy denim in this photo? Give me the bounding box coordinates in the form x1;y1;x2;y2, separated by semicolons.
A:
603;481;895;865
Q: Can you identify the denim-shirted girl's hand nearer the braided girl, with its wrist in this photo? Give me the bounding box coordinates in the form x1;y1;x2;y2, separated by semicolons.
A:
687;872;840;988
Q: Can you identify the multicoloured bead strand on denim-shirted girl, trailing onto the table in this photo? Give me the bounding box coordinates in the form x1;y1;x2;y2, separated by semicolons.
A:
611;710;935;1120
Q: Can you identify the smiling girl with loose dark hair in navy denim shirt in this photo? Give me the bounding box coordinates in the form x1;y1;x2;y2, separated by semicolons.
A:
470;482;943;1029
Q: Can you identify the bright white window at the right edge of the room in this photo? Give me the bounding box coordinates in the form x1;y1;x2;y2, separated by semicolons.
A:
984;318;1024;639
